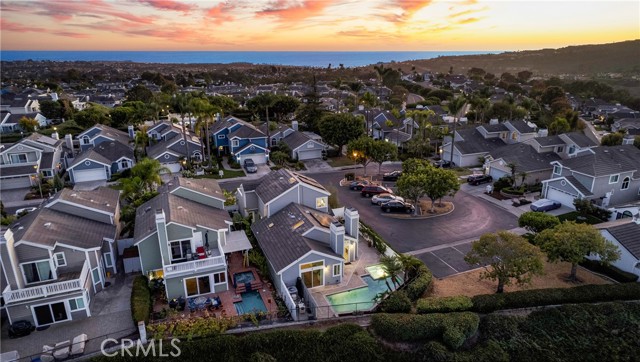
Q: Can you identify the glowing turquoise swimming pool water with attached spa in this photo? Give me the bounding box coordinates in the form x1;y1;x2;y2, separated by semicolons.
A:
327;275;395;314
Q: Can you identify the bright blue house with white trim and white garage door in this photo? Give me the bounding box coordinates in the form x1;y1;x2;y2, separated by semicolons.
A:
211;116;269;164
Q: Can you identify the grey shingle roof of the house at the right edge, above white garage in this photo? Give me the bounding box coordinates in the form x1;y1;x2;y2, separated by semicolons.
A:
560;145;640;176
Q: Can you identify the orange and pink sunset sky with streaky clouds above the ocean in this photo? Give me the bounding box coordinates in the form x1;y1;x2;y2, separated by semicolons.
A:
0;0;640;51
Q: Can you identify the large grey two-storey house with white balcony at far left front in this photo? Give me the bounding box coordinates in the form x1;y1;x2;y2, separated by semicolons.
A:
0;188;120;327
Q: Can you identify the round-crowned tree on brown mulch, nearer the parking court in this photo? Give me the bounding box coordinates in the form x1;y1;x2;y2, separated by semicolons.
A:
464;231;544;293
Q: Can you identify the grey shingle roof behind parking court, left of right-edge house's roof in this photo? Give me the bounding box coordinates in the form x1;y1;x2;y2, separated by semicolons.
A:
490;143;560;172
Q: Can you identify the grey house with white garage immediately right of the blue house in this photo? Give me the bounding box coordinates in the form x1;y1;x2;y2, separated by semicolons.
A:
260;121;326;161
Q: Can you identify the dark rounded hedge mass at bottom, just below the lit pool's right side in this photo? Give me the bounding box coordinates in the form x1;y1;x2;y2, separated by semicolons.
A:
371;312;480;349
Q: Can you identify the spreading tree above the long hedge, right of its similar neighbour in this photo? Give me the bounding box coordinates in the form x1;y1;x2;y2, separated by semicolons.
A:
535;221;620;280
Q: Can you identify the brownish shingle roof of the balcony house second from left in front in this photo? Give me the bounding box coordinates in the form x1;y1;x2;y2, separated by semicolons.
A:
133;187;231;242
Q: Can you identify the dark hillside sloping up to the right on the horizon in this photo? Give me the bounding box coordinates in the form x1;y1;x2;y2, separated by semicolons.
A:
393;39;640;77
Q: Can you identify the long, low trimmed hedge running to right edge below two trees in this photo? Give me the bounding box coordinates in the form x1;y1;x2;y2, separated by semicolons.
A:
471;283;640;313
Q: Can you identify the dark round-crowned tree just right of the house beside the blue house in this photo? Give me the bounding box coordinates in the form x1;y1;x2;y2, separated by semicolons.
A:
320;113;364;152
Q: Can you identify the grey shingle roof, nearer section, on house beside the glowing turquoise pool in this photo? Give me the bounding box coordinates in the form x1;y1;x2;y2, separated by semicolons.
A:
251;203;340;272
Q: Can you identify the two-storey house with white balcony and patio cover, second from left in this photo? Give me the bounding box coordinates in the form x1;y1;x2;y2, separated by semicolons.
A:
134;177;251;299
